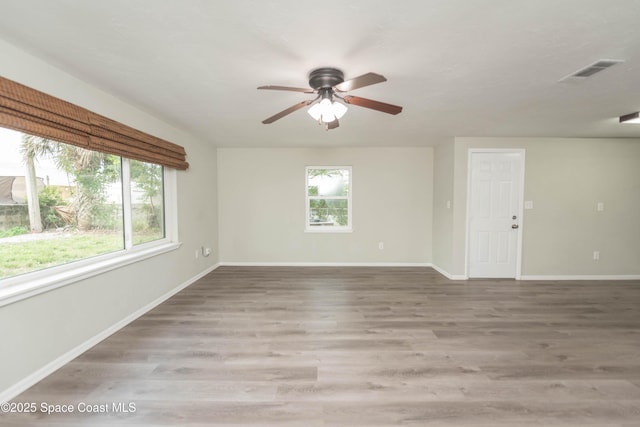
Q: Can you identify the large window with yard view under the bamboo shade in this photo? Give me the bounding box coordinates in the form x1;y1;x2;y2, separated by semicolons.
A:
0;128;166;280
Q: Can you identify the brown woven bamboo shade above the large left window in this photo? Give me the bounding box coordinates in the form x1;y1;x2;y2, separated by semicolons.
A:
0;77;189;170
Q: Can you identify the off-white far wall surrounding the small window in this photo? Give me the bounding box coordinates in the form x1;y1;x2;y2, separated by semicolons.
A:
218;147;433;264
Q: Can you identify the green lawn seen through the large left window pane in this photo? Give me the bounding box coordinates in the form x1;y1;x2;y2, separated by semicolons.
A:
0;233;123;279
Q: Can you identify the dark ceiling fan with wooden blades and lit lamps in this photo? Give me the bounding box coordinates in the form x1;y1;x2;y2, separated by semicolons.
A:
258;67;402;130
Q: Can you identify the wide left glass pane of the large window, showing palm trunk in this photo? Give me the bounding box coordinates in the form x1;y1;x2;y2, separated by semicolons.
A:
0;128;124;279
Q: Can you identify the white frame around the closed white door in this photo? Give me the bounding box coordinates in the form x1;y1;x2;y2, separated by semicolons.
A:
464;148;526;280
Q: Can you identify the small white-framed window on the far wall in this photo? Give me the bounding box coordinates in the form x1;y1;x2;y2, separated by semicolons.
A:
306;166;351;232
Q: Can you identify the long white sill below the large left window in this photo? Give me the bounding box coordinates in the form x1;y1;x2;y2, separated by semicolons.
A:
0;241;181;307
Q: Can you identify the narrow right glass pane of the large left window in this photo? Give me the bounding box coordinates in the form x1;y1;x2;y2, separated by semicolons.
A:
129;160;164;245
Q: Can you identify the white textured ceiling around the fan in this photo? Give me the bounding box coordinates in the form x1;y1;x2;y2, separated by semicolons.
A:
0;0;640;146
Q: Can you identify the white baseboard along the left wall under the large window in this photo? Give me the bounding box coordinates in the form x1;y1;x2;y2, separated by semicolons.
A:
0;264;220;402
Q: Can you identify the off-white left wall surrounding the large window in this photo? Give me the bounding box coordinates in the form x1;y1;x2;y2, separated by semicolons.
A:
0;41;218;394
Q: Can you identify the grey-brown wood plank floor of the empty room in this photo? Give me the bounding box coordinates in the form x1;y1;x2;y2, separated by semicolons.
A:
0;267;640;427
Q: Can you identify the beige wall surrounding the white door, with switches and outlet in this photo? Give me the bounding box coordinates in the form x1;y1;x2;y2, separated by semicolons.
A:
448;138;640;277
